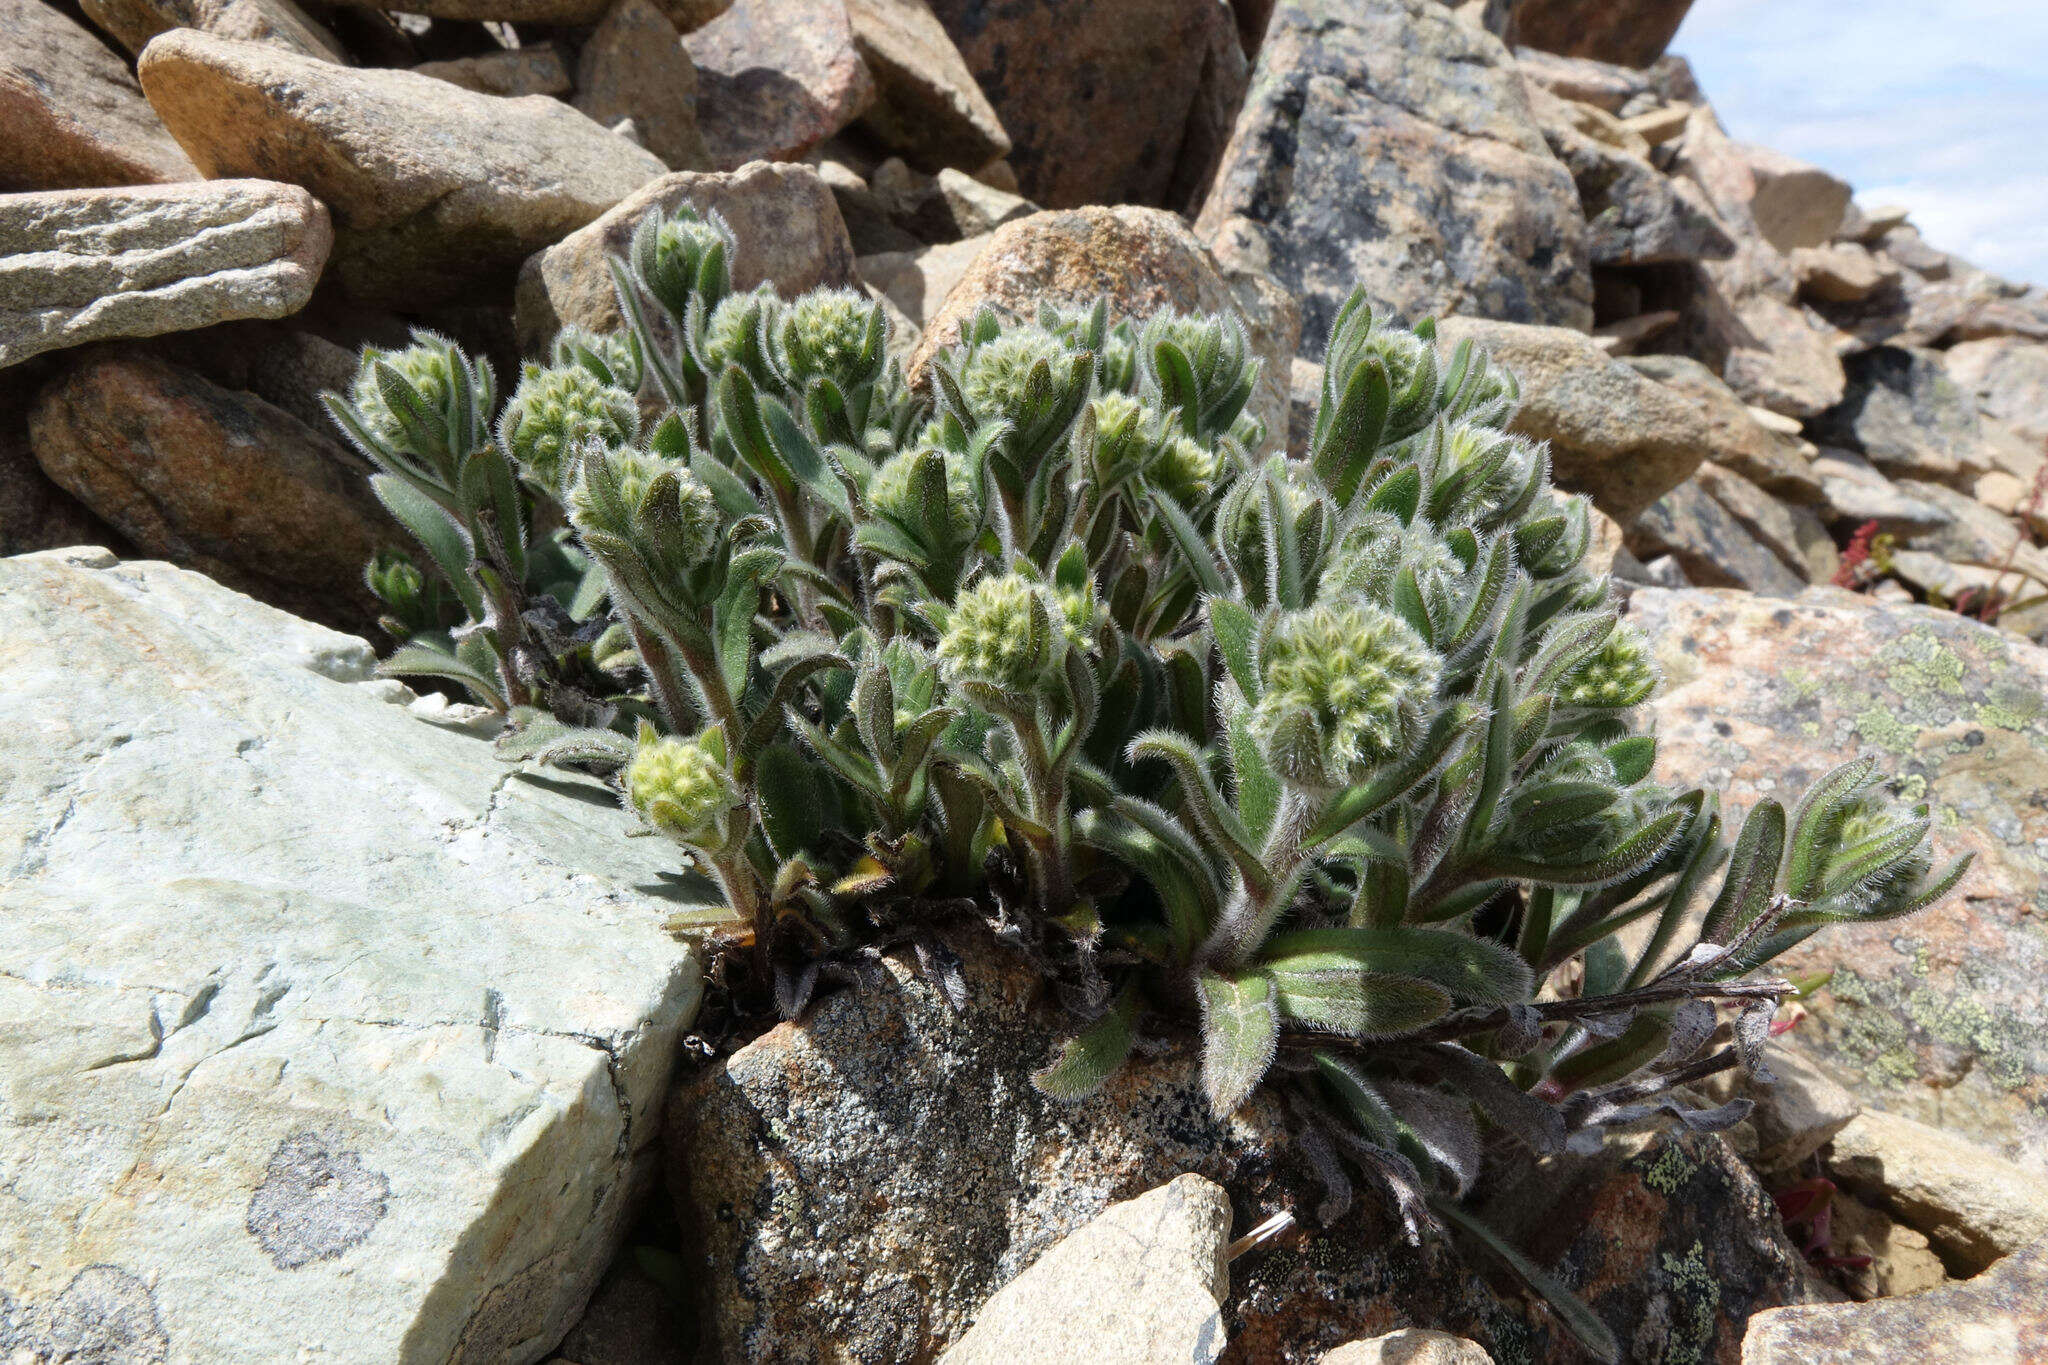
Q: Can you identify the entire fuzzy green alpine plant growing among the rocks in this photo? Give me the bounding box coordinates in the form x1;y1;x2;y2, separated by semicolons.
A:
328;209;1964;1359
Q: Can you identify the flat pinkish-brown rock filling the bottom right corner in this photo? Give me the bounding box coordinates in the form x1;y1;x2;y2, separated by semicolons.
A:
1743;1244;2048;1365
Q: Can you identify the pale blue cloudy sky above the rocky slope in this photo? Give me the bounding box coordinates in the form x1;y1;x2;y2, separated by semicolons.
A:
1671;0;2048;284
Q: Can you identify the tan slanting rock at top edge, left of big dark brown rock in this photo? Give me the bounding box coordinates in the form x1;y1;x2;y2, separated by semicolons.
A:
846;0;1010;172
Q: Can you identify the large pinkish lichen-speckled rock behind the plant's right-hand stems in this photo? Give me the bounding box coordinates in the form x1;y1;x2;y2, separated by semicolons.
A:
1628;587;2048;1175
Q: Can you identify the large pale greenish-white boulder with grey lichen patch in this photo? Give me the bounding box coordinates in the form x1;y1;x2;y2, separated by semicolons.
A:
0;551;700;1363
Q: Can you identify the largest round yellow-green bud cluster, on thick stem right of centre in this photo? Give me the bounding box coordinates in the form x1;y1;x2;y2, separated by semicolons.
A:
1251;602;1442;790
